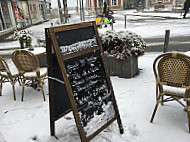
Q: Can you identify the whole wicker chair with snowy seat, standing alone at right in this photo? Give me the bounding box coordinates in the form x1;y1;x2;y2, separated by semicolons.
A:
150;53;190;132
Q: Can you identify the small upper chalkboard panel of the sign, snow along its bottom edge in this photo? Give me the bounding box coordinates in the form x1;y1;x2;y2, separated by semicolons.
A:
55;26;97;55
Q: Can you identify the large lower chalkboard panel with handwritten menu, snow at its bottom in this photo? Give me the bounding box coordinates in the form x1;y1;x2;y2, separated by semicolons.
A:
64;50;115;136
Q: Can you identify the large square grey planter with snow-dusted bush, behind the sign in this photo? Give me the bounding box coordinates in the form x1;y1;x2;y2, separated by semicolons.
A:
100;31;146;78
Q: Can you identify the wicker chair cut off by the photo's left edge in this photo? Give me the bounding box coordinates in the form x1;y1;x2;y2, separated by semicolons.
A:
0;57;19;100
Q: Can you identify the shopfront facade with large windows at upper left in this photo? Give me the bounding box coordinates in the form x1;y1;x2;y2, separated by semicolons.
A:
0;0;51;36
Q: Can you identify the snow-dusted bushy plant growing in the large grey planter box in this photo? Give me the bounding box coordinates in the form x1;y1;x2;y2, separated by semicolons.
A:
100;31;146;60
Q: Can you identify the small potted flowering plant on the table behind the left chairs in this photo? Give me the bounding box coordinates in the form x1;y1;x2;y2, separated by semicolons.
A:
13;30;32;49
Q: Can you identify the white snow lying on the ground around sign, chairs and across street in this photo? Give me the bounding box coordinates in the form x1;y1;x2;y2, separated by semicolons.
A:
0;9;190;142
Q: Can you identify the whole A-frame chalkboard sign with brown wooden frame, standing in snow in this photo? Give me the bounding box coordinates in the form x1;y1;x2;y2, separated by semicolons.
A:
46;22;124;142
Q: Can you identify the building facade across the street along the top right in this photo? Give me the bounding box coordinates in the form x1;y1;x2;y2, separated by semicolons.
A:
86;0;185;14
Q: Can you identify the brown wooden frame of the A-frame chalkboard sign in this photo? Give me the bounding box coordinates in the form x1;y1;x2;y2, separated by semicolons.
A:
45;22;124;142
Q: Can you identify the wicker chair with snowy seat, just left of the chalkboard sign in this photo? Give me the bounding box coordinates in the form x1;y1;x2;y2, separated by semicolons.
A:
12;50;47;101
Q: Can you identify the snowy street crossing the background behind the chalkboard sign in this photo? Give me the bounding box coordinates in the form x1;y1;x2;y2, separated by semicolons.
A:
0;10;190;56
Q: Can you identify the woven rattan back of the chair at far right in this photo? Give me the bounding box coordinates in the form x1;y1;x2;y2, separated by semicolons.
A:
154;53;190;87
